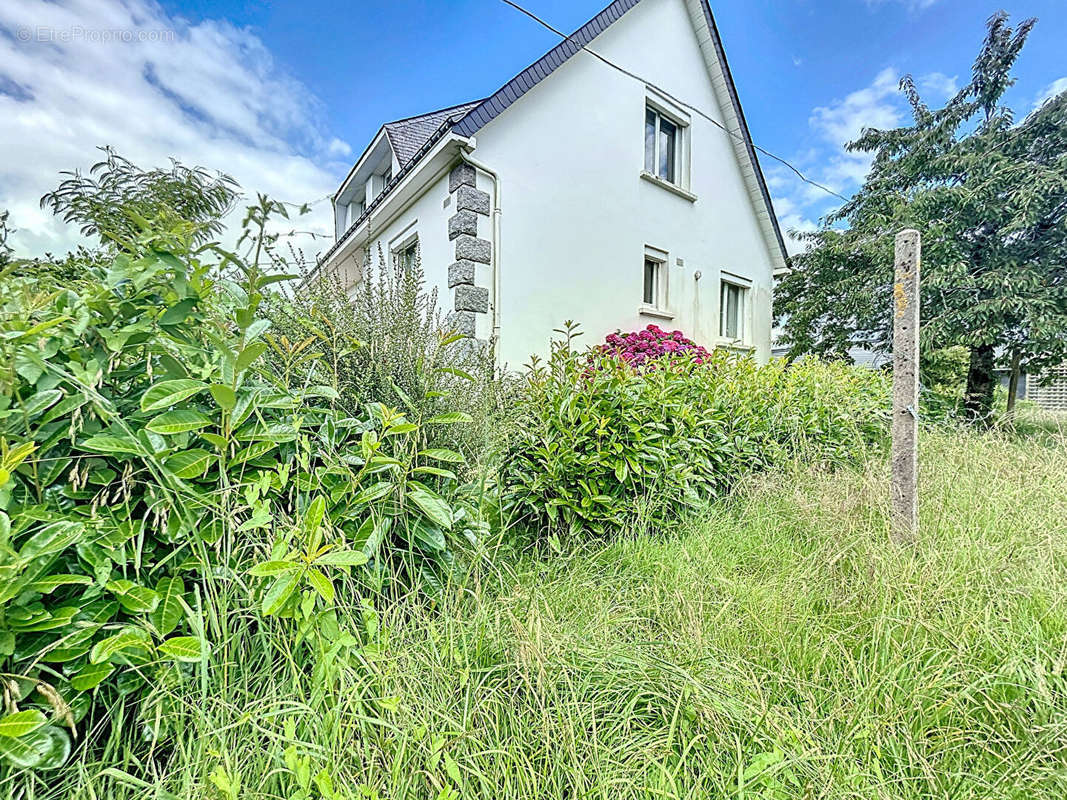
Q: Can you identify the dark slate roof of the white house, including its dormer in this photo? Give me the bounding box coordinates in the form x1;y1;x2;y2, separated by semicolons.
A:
323;0;787;269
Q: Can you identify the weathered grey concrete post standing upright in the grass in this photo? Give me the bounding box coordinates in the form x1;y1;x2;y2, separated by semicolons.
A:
891;228;921;543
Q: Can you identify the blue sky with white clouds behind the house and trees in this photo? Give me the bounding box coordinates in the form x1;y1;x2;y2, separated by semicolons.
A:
0;0;1067;253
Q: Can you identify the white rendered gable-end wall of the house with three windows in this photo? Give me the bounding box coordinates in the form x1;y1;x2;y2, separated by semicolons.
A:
467;0;773;367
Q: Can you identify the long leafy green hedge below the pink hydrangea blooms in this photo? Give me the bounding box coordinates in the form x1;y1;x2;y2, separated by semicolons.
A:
500;331;888;534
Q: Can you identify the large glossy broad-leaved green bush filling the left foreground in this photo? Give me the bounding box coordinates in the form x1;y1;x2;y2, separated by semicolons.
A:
0;197;479;769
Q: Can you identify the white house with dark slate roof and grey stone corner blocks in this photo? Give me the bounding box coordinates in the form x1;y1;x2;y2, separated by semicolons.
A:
320;0;785;366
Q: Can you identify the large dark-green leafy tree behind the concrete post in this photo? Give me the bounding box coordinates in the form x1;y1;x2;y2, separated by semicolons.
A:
775;12;1067;419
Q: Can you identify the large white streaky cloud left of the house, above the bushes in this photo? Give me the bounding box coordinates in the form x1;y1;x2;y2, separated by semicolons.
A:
0;0;351;254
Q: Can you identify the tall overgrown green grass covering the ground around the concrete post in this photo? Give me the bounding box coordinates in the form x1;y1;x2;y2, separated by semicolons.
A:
33;430;1067;800
